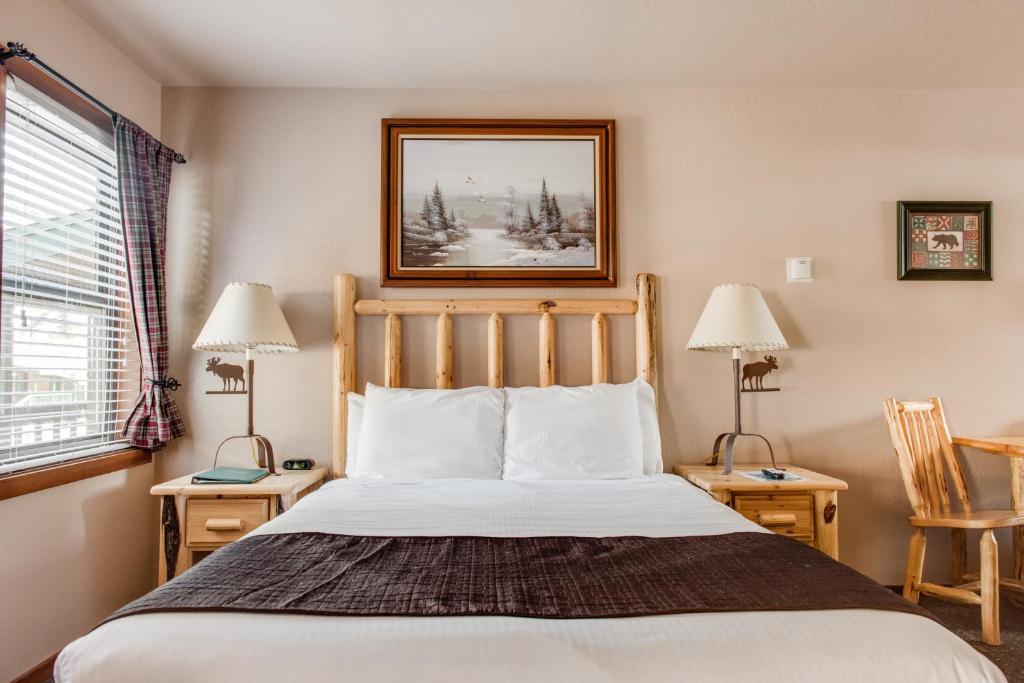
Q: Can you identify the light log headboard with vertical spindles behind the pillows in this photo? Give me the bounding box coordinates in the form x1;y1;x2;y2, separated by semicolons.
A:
331;272;657;478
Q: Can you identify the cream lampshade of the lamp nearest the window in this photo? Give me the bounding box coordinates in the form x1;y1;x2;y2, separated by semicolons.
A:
193;283;299;353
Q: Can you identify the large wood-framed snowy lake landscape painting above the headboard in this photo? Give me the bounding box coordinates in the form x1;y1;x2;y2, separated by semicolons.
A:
381;119;615;287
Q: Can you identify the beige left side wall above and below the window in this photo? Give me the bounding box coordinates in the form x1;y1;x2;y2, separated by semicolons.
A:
0;0;160;681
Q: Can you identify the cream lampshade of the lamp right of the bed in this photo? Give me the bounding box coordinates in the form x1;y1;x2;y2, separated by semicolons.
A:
686;285;790;351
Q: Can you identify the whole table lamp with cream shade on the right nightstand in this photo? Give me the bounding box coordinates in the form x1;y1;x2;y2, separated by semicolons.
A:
686;285;790;474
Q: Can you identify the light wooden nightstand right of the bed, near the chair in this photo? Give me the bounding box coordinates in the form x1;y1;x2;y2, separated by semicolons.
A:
672;465;848;559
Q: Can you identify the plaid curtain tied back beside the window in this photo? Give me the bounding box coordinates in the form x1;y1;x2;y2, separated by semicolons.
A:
114;115;185;449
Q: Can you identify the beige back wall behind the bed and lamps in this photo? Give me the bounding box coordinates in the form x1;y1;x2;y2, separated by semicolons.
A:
158;88;1024;583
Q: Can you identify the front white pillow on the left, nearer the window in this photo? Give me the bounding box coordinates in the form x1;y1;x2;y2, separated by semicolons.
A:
352;384;505;479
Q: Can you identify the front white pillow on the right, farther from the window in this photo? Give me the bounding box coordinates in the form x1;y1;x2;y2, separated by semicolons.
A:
502;384;643;479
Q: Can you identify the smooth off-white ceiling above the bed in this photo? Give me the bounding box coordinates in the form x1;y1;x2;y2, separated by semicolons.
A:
61;0;1024;88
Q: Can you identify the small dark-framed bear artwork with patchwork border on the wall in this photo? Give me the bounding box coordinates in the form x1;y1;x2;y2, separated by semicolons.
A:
896;202;992;280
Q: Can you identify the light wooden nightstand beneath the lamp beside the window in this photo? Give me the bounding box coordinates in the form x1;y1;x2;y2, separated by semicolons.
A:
150;467;327;584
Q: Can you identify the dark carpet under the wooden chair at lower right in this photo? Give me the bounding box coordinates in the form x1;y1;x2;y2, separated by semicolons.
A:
921;590;1024;683
